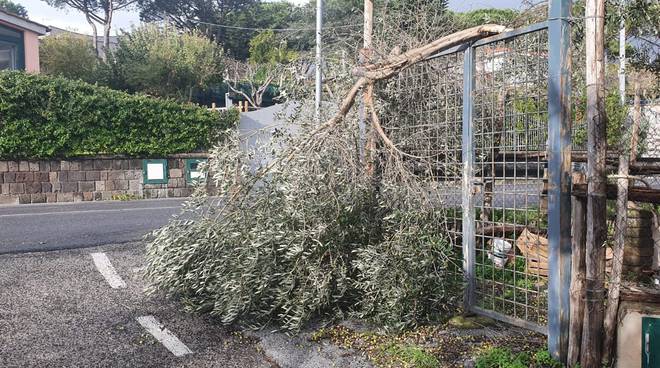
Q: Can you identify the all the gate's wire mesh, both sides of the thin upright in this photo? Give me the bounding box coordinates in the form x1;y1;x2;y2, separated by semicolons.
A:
377;25;548;329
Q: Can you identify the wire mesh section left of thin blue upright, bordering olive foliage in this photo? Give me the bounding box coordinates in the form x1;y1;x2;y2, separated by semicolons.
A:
377;52;464;278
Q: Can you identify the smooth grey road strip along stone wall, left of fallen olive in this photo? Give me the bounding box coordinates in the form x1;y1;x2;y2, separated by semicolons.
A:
0;199;185;254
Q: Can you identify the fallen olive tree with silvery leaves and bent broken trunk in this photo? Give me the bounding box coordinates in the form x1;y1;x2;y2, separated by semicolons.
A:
147;25;504;331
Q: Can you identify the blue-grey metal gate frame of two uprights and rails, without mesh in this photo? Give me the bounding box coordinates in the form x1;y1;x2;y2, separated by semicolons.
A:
454;0;571;361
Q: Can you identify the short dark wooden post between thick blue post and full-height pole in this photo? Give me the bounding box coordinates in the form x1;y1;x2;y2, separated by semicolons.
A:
566;172;587;367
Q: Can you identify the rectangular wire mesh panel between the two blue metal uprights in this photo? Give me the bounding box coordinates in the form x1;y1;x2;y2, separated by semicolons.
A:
473;30;549;326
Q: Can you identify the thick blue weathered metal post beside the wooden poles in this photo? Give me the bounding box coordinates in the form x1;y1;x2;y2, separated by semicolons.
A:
548;0;571;362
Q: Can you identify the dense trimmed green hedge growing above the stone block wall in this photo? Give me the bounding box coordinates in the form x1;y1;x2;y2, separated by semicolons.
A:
0;72;238;159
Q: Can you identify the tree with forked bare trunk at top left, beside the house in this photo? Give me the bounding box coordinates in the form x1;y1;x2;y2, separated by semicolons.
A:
44;0;137;59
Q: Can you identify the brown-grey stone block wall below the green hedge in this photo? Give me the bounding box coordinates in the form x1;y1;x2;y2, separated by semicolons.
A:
0;154;205;205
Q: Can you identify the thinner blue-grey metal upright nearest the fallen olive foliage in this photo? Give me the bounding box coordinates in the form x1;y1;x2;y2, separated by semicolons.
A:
461;46;476;312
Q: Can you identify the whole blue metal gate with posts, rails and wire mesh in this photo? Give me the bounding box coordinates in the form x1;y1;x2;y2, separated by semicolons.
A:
376;0;571;359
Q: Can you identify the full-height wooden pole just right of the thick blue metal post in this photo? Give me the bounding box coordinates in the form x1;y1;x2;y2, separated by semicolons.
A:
580;0;607;368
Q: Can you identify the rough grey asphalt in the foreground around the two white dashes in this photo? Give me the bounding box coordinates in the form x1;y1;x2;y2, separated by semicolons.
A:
0;243;272;368
